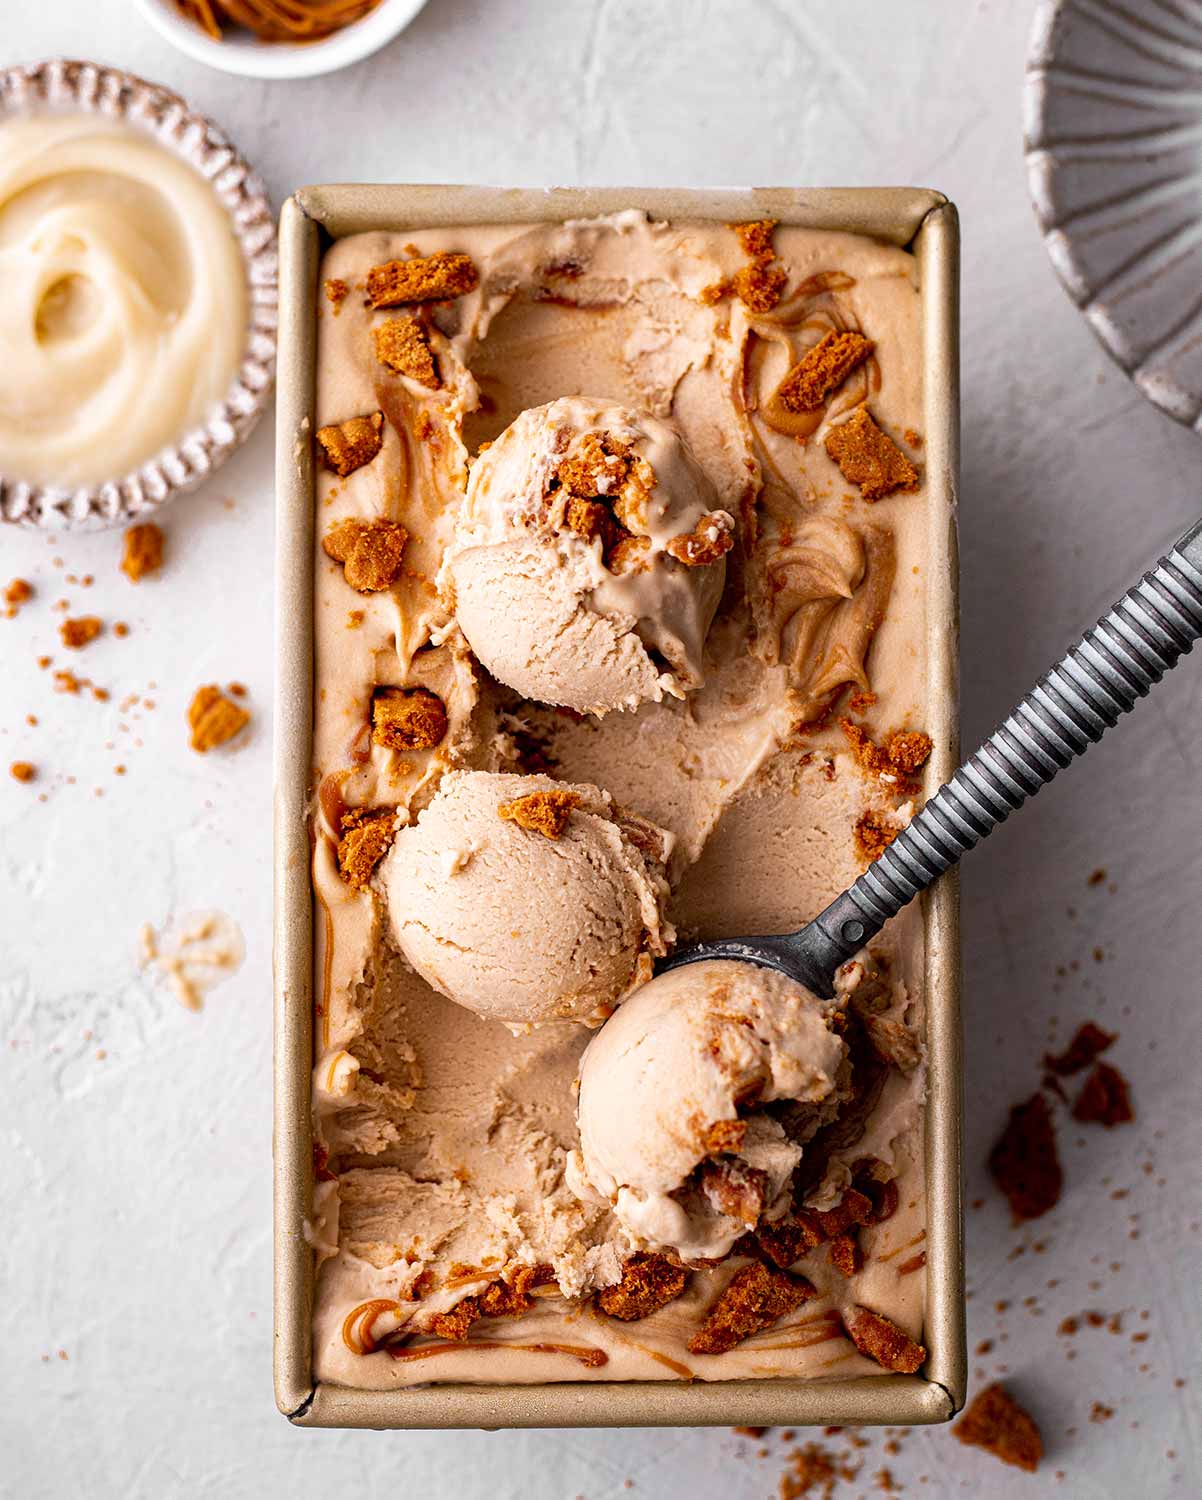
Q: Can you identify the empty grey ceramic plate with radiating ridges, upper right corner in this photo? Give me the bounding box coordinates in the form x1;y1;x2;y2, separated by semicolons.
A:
1023;0;1202;431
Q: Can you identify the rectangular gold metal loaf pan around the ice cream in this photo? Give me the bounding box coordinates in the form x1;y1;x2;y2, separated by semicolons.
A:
273;185;966;1428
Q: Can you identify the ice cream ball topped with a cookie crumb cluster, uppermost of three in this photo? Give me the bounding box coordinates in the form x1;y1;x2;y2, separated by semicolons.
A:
441;396;734;714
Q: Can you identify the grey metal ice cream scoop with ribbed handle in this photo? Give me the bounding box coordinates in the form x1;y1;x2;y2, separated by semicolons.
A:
662;522;1202;999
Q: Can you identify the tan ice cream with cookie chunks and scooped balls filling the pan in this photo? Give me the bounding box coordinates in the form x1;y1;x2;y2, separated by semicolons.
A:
311;213;930;1388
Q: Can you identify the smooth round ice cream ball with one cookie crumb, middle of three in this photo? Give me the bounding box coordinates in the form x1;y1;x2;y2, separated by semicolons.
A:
381;771;674;1028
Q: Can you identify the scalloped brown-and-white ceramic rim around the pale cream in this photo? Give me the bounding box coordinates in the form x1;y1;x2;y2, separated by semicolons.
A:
0;59;279;531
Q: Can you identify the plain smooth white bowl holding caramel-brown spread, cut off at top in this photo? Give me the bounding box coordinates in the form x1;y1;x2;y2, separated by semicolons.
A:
138;0;426;78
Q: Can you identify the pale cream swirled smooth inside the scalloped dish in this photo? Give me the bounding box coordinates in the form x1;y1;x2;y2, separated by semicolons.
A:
0;114;248;486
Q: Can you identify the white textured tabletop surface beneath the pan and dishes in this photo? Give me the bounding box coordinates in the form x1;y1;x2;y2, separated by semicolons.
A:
0;0;1202;1500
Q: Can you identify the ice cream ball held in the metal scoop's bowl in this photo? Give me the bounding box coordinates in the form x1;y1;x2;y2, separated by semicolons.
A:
569;960;848;1260
